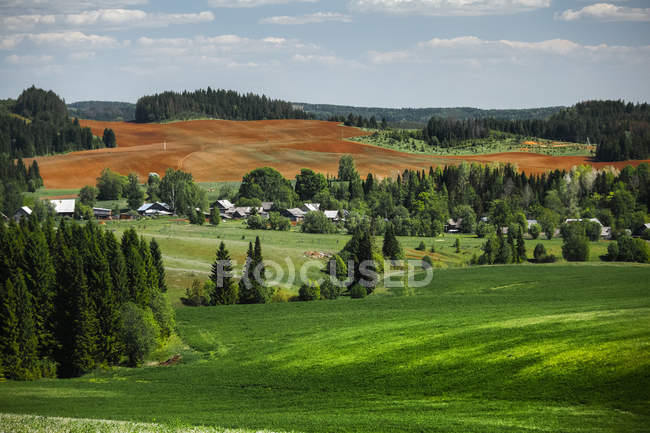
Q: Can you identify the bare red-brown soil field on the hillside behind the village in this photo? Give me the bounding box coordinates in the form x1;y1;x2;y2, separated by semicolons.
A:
29;120;641;188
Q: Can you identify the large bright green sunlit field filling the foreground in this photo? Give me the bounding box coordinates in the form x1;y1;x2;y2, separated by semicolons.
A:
0;262;650;432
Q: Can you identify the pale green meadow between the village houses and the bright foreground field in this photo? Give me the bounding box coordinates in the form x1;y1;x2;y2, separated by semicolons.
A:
100;218;608;302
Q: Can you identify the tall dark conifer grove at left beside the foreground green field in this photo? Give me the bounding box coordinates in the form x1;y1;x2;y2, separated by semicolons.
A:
0;216;175;380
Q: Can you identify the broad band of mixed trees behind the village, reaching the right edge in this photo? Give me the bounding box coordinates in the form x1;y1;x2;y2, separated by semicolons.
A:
229;155;650;240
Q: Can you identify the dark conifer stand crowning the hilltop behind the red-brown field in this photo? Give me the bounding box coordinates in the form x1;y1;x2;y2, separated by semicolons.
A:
135;87;311;122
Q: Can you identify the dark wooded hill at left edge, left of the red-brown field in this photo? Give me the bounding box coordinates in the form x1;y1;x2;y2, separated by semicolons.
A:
0;86;104;158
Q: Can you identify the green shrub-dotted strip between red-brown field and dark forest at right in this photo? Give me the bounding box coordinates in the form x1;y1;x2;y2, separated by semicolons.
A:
349;129;592;156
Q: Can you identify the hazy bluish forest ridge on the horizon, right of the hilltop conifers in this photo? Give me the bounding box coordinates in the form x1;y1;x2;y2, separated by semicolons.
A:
296;103;564;128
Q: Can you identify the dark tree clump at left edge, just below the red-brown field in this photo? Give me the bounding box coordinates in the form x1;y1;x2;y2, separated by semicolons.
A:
0;154;43;217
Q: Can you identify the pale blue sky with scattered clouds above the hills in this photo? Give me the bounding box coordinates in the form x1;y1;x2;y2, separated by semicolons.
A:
0;0;650;108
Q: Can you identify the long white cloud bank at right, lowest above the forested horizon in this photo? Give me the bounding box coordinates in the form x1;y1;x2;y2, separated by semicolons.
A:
368;36;650;65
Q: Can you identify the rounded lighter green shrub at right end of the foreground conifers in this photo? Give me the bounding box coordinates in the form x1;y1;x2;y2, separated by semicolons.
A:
120;302;160;367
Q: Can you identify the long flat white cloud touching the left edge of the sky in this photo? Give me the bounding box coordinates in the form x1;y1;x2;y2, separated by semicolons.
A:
0;32;119;50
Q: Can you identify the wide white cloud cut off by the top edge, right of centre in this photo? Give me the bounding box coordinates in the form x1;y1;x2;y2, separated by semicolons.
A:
349;0;551;16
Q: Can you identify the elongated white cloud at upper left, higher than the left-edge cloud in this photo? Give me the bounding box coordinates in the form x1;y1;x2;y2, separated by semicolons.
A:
65;9;214;27
